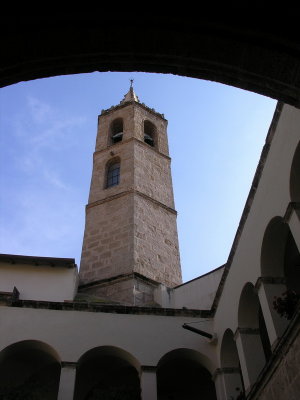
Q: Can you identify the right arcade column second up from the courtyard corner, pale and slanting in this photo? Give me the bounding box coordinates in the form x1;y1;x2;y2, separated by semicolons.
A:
234;328;265;393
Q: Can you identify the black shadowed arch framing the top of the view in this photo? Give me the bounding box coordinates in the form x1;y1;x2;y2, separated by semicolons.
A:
0;11;300;106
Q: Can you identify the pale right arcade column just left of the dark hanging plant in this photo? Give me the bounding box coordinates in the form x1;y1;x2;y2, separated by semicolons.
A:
255;277;287;348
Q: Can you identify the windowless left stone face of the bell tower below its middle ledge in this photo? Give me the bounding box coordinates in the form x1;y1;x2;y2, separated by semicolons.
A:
79;193;134;284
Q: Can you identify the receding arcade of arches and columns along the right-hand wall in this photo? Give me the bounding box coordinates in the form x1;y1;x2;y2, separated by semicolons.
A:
215;133;300;399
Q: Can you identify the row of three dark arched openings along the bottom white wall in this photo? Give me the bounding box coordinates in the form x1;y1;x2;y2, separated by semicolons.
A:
0;340;216;400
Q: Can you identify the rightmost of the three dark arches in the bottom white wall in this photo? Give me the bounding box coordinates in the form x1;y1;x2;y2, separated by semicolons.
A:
157;348;216;400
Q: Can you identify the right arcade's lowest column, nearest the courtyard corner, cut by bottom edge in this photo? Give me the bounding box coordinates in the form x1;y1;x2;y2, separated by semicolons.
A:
213;367;243;400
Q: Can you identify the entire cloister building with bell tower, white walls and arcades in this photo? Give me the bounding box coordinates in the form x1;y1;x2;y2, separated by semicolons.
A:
0;88;300;400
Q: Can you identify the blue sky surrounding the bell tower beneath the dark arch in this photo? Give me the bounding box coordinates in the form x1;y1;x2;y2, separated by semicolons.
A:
0;72;276;281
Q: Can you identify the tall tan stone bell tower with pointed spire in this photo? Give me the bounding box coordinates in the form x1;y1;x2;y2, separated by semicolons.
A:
79;84;182;305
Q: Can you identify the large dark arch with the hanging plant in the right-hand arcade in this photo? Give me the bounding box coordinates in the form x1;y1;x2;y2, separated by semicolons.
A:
258;216;300;342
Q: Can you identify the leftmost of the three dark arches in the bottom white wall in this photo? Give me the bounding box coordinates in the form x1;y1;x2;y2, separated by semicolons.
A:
0;340;61;400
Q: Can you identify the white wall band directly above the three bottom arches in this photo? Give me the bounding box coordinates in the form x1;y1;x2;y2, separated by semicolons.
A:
0;306;216;373
